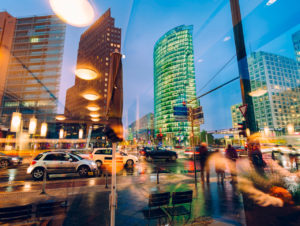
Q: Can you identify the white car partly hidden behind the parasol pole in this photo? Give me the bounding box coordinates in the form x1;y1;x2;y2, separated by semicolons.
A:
92;148;138;168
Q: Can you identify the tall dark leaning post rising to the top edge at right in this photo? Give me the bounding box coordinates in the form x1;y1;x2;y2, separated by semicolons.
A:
230;0;257;133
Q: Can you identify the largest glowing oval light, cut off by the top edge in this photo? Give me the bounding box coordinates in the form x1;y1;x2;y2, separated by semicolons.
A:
50;0;95;27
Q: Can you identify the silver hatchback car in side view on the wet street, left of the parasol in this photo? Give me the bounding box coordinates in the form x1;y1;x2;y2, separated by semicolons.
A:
27;151;97;180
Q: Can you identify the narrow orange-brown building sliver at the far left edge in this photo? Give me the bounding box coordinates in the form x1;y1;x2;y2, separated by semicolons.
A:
0;12;16;106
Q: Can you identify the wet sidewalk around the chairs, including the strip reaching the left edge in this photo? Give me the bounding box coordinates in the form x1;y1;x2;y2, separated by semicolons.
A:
0;174;245;226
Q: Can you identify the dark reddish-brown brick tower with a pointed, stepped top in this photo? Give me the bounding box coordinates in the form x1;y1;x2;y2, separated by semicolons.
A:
65;9;121;119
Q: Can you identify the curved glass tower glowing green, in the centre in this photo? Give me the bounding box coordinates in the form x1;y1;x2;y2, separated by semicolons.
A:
153;25;200;145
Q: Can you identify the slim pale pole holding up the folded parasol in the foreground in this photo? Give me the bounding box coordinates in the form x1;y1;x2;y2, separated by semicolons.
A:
110;143;117;226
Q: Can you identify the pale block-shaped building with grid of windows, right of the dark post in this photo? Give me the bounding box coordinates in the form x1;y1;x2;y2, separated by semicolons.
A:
248;52;300;130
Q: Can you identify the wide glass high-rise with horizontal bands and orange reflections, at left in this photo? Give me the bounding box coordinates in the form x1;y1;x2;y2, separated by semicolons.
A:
2;15;66;120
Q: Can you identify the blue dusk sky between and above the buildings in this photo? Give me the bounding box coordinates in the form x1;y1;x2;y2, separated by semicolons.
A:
0;0;300;130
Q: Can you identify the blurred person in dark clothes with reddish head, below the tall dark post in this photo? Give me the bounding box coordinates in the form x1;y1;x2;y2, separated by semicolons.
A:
248;142;267;176
